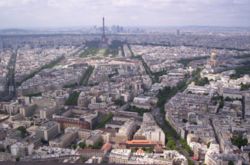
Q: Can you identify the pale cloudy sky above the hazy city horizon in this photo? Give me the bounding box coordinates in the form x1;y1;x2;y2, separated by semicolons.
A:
0;0;250;29
